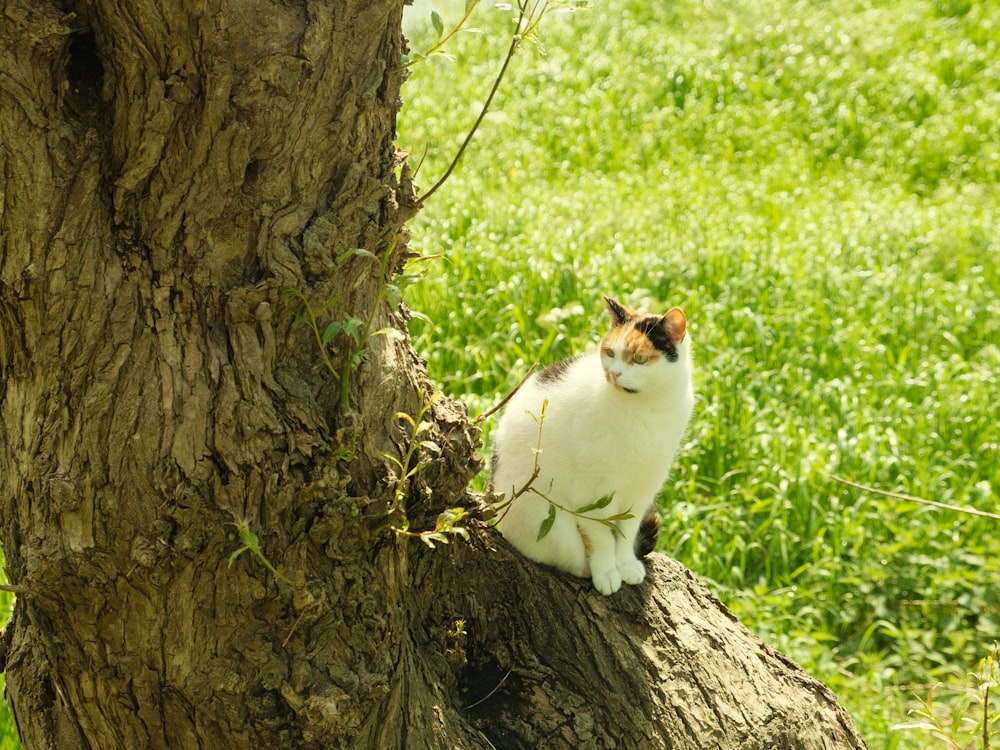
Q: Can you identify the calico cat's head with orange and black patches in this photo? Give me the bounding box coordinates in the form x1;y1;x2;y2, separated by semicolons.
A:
601;296;691;394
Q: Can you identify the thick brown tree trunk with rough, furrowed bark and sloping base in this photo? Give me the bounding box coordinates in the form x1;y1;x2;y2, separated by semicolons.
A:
0;0;863;750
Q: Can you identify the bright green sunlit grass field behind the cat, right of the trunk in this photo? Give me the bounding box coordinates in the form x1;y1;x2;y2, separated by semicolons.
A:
399;0;1000;749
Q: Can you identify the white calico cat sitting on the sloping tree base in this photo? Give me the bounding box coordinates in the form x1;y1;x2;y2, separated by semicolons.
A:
492;296;694;595
